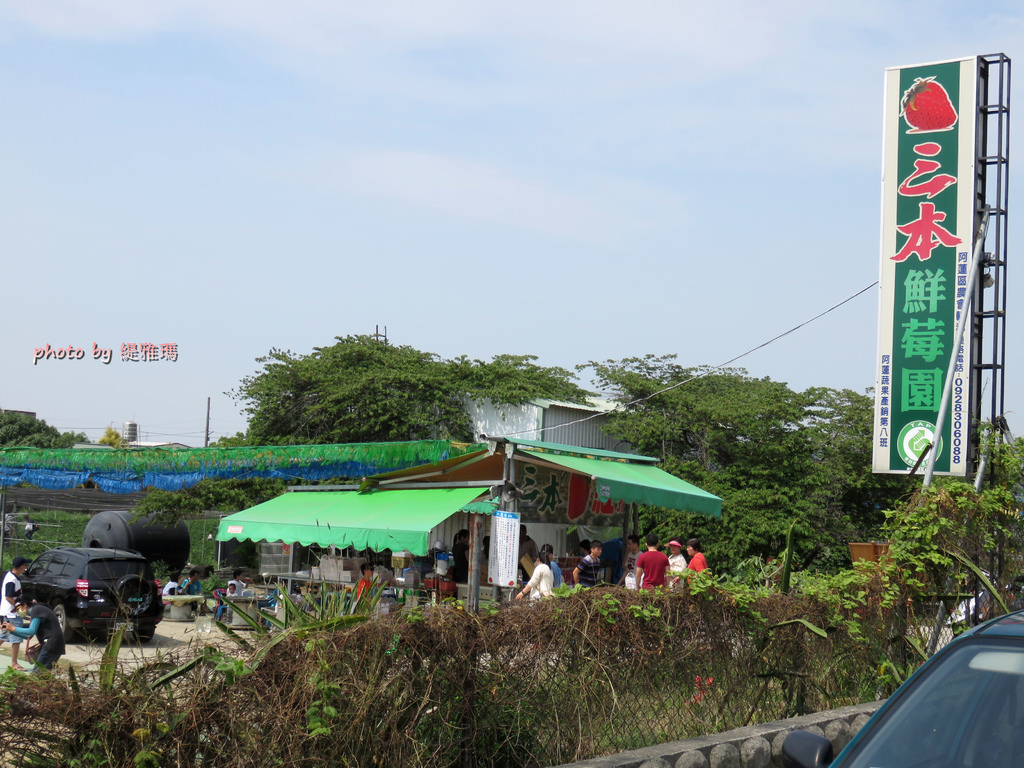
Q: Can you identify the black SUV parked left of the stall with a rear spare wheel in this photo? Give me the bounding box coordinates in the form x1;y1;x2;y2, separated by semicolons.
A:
22;547;164;641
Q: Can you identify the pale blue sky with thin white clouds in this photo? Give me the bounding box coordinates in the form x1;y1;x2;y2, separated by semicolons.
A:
0;0;1024;445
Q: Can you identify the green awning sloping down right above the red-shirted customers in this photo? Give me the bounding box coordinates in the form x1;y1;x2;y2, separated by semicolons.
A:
516;444;722;517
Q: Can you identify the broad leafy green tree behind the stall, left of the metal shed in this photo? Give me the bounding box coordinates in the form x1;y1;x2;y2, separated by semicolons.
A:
228;336;587;445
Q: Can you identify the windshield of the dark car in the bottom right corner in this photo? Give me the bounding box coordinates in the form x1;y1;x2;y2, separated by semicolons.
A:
842;640;1024;768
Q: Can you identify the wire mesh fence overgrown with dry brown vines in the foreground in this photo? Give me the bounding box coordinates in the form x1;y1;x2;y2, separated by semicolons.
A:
0;588;907;768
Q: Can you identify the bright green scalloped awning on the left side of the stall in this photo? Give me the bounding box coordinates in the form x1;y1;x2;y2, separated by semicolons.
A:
217;487;487;555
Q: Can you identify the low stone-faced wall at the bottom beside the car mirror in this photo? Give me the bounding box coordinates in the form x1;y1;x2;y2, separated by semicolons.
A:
559;701;883;768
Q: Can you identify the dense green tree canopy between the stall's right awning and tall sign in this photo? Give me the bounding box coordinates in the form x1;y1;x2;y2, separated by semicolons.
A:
589;355;911;569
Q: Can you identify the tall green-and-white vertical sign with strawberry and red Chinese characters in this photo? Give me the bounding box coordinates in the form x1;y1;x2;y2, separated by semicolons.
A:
873;57;978;475
